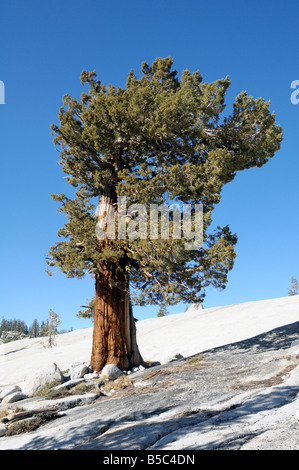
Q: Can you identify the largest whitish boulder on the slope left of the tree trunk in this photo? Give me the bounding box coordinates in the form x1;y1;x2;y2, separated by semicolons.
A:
22;363;65;396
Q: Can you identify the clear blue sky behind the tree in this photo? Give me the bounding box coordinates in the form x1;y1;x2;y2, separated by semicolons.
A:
0;0;299;328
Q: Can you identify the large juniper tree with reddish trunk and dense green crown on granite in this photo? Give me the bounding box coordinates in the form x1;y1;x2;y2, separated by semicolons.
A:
48;57;282;370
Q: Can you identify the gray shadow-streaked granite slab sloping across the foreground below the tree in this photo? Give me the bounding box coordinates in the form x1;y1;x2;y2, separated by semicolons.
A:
0;322;299;451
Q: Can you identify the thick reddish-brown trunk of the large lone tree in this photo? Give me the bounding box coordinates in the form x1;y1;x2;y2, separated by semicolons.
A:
90;189;142;372
